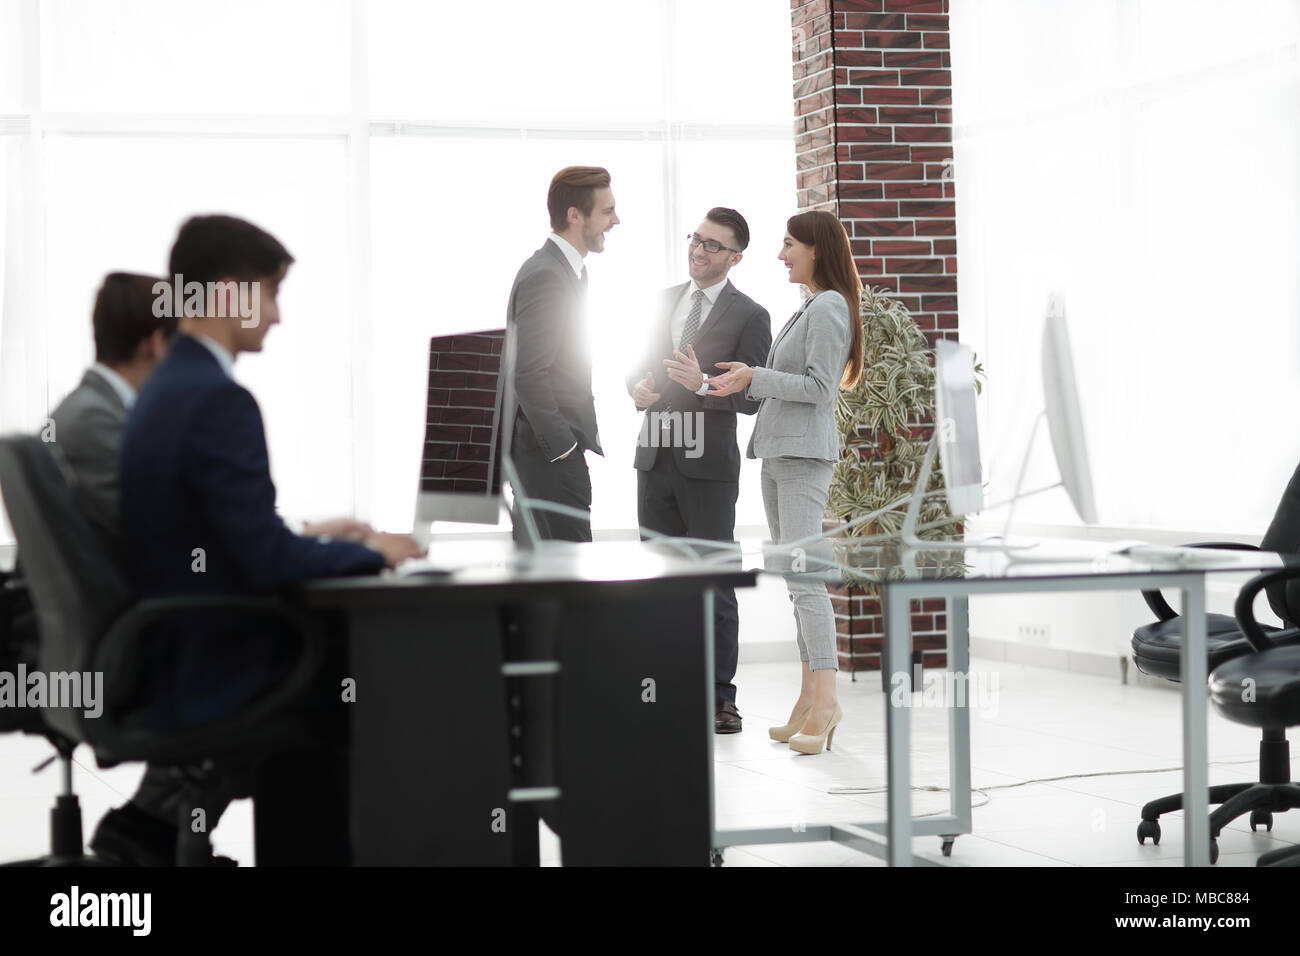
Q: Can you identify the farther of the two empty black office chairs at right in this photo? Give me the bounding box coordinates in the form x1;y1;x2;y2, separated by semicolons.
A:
1132;467;1300;861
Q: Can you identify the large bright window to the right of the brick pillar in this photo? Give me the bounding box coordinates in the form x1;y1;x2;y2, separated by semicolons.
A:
952;0;1300;536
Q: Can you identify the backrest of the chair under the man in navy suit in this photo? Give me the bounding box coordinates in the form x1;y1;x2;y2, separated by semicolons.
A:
0;436;131;741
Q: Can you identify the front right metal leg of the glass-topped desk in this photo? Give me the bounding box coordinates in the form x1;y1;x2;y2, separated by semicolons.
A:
1182;575;1210;866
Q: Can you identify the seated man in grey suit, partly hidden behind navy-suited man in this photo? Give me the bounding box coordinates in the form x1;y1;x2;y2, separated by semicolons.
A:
49;272;177;542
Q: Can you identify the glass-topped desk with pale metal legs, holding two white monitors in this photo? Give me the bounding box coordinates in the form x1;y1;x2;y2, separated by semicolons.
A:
714;542;1283;866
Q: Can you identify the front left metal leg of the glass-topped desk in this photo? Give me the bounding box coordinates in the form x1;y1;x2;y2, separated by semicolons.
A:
884;588;913;866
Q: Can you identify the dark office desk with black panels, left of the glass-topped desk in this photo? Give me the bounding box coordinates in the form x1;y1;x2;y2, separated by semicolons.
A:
302;542;755;866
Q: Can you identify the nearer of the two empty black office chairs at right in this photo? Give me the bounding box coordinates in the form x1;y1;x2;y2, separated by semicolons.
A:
1209;559;1300;866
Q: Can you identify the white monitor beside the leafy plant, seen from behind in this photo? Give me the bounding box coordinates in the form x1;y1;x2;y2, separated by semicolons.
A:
922;338;984;515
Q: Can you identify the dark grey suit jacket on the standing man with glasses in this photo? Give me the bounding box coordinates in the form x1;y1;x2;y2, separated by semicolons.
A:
627;280;772;481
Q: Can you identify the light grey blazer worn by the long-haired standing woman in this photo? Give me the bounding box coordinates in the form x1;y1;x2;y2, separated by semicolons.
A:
746;289;852;462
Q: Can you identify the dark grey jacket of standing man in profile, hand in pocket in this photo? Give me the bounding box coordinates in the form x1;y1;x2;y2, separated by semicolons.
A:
506;239;603;459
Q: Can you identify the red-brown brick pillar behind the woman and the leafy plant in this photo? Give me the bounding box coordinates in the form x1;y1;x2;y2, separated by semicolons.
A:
790;0;957;670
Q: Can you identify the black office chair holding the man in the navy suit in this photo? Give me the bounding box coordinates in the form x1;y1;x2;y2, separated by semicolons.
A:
0;436;325;866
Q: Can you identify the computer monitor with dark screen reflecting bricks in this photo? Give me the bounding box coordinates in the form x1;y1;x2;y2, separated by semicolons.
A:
415;329;514;544
